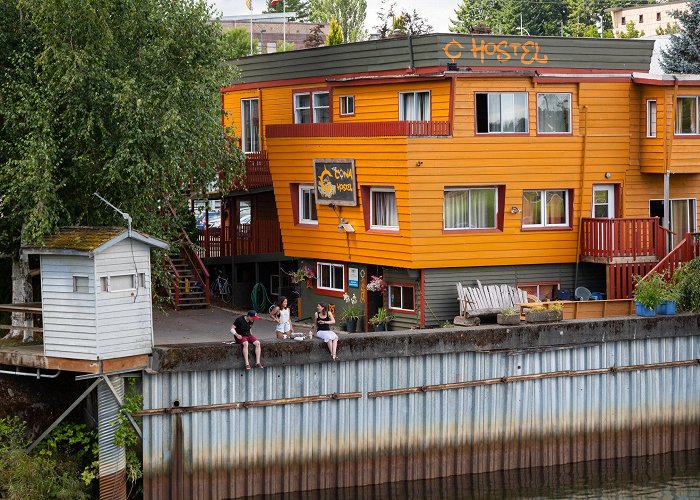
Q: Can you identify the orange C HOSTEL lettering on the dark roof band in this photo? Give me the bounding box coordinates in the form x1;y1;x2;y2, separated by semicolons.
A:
442;38;549;66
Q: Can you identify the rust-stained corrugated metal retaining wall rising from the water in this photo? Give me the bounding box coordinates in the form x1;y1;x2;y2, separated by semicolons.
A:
143;336;700;499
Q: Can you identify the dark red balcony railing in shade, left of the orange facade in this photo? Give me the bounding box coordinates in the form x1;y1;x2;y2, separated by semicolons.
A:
198;219;282;258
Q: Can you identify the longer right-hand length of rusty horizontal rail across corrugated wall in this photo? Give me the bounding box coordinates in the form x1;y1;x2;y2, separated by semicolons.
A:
367;359;700;398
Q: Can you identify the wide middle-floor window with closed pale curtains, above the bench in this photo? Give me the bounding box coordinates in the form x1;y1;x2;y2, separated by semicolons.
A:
443;187;498;229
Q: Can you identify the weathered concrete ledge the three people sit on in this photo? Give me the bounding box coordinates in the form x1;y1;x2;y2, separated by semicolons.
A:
149;314;700;372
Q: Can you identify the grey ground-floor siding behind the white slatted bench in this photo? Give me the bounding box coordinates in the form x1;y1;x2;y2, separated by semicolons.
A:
425;263;605;326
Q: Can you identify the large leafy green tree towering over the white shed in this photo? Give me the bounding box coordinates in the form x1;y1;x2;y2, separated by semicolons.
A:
0;0;243;332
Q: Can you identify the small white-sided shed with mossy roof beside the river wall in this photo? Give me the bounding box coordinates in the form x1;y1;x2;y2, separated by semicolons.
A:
23;227;168;360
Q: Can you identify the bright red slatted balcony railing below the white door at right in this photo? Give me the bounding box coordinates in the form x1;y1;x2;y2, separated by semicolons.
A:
581;217;665;260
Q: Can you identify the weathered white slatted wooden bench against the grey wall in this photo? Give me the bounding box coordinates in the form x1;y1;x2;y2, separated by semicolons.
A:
455;280;527;325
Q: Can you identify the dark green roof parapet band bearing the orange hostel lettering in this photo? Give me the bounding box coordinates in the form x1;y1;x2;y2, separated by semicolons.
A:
228;33;654;84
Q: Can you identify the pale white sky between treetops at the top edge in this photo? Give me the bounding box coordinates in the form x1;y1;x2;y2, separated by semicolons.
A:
210;0;461;33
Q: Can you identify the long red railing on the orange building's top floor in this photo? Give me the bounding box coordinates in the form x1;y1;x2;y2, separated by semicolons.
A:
265;121;450;139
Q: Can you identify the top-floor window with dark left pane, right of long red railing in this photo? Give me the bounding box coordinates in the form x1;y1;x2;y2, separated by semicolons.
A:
476;92;528;134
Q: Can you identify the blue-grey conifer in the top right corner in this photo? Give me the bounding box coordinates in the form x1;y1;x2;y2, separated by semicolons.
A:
661;0;700;75
